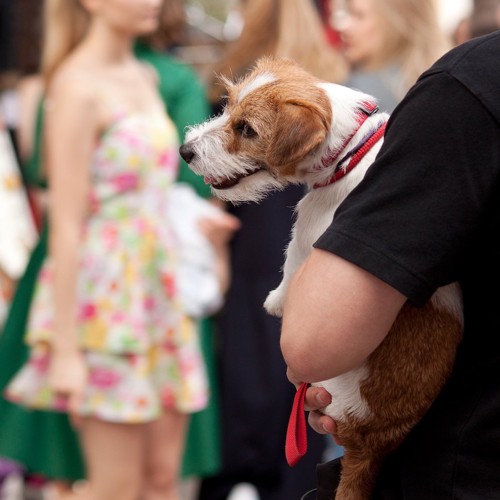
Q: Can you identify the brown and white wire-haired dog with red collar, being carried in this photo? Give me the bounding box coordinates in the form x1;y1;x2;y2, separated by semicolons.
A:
180;58;462;500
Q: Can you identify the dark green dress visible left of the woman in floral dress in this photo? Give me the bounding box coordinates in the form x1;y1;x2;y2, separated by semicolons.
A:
0;99;85;480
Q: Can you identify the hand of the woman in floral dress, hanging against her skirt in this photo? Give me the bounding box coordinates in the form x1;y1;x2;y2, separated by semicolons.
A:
49;350;88;414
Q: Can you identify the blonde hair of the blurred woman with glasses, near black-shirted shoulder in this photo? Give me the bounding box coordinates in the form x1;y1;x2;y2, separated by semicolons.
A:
372;0;452;97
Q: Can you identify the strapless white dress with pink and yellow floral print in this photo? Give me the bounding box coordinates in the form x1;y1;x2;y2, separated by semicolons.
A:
6;113;208;423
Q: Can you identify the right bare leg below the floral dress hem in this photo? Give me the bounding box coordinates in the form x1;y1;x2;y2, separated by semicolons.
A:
140;410;189;500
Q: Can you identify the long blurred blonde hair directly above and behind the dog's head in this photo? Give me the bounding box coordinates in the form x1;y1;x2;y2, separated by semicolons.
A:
209;0;347;102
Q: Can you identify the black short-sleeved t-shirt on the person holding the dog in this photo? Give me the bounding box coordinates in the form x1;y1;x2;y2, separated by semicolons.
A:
315;32;500;500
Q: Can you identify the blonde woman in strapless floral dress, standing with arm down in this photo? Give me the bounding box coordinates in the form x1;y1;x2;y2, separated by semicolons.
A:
0;0;230;500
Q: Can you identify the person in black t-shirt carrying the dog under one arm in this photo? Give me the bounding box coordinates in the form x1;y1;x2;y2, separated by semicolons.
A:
281;31;500;500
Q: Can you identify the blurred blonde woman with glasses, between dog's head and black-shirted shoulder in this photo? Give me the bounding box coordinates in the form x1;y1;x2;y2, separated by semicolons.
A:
340;0;451;112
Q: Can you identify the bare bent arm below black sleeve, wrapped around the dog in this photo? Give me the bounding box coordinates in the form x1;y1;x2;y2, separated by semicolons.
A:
281;249;406;382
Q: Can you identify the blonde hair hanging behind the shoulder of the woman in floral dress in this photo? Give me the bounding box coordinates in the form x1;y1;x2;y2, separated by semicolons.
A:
41;0;89;83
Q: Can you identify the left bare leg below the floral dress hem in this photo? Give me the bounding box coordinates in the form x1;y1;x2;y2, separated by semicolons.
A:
79;418;145;500
